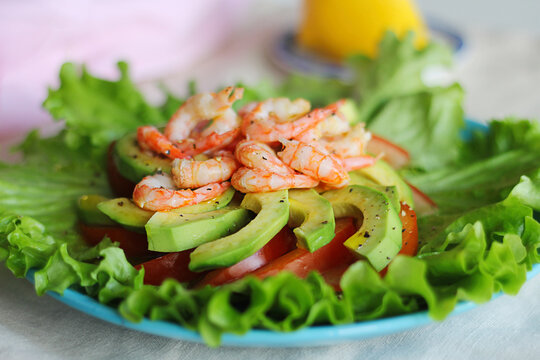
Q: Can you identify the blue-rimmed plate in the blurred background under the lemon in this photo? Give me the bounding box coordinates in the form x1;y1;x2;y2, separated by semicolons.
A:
270;19;465;80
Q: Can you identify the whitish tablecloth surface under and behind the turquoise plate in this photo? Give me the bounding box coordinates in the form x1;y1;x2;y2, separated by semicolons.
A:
0;1;540;360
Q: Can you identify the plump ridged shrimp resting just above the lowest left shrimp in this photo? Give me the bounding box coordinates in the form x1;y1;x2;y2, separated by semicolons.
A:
171;151;238;188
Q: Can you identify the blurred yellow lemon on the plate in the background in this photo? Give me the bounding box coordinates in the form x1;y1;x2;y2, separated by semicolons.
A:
297;0;428;60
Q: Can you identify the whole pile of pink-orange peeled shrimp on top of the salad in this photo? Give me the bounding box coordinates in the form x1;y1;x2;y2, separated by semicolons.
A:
133;87;376;211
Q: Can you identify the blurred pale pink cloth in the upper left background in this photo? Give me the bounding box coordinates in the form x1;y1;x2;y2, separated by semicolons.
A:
0;0;239;141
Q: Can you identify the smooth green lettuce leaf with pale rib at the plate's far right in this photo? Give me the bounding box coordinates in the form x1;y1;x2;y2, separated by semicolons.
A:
405;118;540;214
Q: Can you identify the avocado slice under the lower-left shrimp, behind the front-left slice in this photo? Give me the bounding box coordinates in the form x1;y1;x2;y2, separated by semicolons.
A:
97;187;235;232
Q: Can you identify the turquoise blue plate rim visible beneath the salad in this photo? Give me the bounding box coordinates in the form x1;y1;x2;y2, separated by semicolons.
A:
26;120;540;347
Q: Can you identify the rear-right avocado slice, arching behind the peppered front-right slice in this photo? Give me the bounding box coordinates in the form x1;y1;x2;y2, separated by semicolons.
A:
349;159;414;209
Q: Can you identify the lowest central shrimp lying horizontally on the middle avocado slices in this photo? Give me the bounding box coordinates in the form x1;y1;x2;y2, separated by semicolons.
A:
231;167;319;193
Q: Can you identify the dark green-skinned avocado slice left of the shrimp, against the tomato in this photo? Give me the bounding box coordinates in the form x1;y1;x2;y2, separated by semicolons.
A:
113;133;172;183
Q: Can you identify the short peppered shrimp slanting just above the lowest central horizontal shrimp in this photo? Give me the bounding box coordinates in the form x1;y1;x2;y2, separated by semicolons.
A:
235;140;294;175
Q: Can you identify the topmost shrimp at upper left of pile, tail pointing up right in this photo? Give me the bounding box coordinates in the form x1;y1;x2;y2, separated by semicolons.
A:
165;86;244;141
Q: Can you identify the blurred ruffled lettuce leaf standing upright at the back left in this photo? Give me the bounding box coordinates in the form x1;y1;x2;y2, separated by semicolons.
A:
43;62;168;153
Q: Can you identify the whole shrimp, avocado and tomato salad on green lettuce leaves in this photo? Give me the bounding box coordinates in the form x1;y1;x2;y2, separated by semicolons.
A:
0;33;540;346
